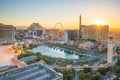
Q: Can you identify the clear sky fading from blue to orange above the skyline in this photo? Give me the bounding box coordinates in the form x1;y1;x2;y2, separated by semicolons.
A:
0;0;120;29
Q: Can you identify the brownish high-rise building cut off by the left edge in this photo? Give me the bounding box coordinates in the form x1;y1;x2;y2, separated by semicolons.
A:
0;24;16;44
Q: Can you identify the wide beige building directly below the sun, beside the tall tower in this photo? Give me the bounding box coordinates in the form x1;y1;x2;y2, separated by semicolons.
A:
81;25;109;41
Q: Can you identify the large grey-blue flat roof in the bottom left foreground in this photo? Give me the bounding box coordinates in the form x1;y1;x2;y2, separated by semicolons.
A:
0;63;63;80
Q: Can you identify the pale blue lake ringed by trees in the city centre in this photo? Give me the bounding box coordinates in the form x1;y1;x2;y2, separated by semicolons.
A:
32;45;86;59
